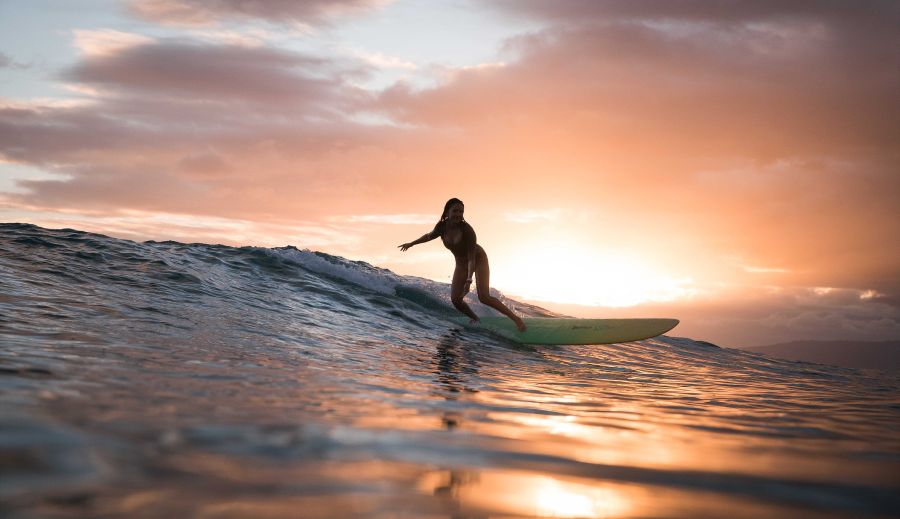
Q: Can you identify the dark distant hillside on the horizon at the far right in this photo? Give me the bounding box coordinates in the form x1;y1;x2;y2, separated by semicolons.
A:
744;341;900;371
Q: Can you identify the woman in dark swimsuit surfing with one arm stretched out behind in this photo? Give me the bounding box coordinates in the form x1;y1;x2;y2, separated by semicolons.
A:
399;198;525;332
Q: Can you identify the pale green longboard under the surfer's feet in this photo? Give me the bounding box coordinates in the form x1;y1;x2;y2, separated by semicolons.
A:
456;317;679;345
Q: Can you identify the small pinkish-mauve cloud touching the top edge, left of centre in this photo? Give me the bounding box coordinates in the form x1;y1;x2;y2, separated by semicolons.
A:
129;0;387;26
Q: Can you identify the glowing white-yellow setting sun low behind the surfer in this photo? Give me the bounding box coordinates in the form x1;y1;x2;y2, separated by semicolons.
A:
491;242;692;307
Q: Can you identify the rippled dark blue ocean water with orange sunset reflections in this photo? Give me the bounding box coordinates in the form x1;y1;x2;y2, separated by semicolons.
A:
0;224;900;518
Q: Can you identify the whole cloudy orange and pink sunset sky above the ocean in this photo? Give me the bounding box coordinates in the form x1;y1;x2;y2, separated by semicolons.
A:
0;0;900;347
